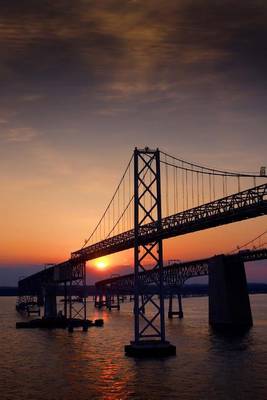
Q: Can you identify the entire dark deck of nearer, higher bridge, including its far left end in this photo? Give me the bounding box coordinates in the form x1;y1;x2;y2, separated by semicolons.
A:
19;184;267;293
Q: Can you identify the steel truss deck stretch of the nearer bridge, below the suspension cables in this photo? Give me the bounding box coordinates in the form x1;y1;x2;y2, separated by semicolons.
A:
72;184;267;261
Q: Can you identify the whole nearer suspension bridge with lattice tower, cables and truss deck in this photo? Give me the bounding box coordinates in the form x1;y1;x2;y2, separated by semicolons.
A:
19;148;267;355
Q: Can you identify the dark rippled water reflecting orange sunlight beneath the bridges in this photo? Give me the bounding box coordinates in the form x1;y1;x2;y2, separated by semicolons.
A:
0;295;267;400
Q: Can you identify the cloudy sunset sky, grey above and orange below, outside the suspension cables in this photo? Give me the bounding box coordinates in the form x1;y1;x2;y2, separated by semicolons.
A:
0;0;267;286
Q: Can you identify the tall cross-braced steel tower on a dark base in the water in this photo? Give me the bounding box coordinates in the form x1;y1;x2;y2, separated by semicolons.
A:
125;147;176;356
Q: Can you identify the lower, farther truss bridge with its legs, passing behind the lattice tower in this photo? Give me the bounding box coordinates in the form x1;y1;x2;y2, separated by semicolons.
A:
95;248;267;318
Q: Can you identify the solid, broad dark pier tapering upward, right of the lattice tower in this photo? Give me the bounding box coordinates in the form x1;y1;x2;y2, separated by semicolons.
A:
209;255;253;332
